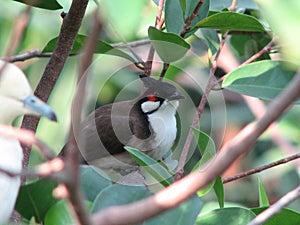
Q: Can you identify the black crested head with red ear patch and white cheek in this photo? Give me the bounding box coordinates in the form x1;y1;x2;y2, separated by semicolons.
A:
140;76;185;114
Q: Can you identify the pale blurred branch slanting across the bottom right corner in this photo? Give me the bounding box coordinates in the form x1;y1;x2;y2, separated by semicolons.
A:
248;186;300;225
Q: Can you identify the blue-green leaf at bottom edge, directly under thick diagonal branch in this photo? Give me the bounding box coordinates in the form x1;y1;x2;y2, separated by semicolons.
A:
142;195;202;225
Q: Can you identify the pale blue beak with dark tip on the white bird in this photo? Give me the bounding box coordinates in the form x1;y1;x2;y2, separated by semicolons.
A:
22;95;57;122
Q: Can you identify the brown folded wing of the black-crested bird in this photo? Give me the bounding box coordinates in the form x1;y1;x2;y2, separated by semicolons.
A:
79;102;132;161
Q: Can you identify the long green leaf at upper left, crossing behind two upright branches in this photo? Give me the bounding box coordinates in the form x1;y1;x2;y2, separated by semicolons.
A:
42;34;135;62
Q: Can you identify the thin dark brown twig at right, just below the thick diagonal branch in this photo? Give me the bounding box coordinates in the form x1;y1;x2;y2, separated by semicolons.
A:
223;153;300;184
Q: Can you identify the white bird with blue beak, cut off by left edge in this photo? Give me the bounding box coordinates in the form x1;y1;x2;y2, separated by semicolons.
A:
0;60;57;224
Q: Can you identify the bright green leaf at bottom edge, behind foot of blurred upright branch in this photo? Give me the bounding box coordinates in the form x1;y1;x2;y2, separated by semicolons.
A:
44;200;92;225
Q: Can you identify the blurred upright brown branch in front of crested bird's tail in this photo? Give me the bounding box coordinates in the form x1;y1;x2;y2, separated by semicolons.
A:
65;11;102;225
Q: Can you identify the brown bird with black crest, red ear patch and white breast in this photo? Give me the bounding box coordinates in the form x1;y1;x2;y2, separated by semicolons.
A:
62;75;185;175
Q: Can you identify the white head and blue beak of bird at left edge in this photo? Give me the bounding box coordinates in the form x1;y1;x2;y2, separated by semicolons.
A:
0;60;57;124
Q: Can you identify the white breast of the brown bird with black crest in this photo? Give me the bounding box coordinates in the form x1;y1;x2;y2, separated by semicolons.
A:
148;101;179;160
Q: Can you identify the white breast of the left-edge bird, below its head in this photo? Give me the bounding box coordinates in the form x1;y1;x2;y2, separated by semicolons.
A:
0;136;23;224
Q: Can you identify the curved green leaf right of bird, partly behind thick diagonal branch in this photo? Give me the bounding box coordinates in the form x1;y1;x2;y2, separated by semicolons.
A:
193;128;216;196
